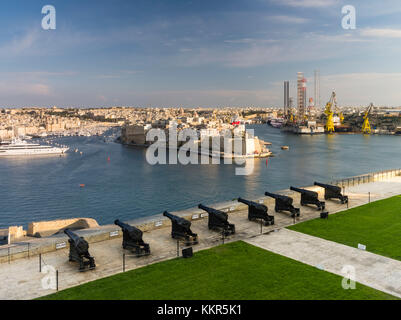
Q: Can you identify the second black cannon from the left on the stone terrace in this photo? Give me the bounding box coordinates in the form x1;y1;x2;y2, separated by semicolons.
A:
114;219;150;257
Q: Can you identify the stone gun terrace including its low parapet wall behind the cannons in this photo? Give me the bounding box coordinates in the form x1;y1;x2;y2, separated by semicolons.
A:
0;170;401;299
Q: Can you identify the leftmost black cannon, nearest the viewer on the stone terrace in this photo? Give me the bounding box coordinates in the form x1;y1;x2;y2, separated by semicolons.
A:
64;229;96;271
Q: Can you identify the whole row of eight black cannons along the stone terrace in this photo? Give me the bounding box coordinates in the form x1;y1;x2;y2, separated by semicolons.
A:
64;182;348;271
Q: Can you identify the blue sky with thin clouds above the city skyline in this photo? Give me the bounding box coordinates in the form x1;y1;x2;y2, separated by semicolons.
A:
0;0;401;107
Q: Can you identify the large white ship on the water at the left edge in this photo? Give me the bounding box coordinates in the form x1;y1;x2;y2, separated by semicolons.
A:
0;139;69;157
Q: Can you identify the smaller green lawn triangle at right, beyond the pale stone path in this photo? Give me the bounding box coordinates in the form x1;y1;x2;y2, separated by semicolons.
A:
288;196;401;260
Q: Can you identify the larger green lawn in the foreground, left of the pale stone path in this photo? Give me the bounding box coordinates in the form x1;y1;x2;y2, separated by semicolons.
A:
42;241;395;300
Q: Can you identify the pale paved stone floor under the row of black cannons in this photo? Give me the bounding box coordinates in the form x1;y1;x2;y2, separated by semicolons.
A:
0;176;401;299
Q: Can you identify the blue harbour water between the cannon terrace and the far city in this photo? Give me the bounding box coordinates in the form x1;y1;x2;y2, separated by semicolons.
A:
0;125;401;228
